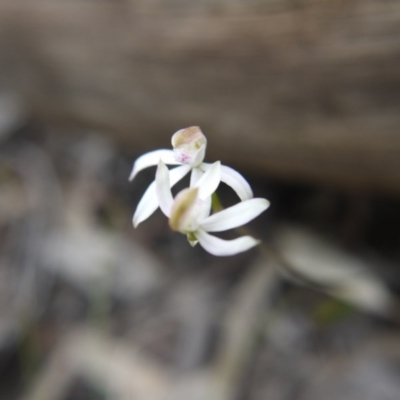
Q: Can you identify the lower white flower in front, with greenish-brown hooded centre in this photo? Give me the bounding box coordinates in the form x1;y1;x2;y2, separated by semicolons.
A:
156;161;269;256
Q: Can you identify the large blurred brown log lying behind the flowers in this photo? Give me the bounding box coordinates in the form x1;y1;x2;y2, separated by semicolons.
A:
0;0;400;193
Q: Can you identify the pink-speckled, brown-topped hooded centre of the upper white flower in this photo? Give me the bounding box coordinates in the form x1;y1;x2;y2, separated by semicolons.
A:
172;126;207;167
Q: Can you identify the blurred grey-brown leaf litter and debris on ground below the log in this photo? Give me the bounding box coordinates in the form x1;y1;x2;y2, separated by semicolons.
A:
0;123;400;400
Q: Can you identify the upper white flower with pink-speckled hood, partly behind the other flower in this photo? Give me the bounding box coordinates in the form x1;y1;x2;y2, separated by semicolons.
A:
129;126;253;228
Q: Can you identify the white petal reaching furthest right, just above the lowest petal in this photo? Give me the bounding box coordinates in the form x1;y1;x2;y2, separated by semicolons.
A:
200;198;269;232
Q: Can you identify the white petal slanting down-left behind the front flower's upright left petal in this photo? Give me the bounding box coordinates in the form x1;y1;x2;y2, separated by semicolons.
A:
133;165;190;228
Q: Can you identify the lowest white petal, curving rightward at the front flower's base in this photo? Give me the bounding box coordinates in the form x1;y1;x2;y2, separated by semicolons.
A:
196;229;260;256
